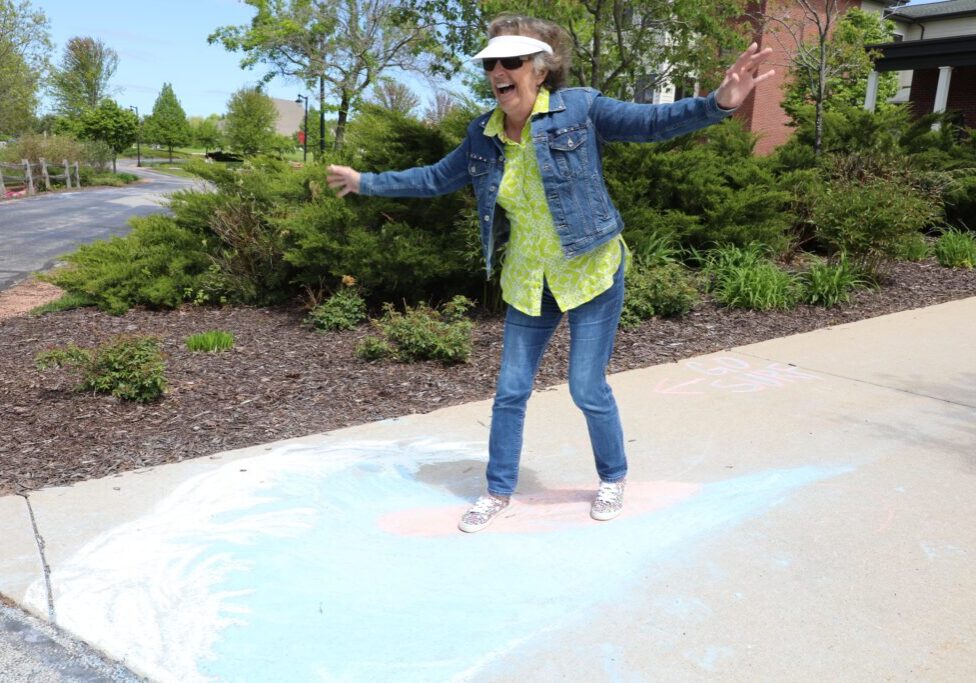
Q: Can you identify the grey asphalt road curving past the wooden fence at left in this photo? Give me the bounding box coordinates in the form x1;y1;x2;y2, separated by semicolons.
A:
0;164;202;291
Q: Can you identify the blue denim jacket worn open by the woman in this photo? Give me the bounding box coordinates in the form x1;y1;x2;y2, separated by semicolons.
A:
359;88;732;277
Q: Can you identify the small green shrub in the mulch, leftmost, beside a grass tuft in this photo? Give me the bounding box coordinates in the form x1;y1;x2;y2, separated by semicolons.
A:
35;337;166;403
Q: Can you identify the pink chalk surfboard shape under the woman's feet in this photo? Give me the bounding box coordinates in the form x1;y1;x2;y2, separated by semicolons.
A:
377;481;701;538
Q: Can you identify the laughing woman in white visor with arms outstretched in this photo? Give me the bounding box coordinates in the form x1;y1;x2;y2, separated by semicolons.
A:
328;15;773;532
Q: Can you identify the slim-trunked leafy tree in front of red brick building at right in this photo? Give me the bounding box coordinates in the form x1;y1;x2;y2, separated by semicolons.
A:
755;0;897;156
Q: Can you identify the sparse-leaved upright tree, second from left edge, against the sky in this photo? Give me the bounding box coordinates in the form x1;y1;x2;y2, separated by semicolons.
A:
49;36;119;117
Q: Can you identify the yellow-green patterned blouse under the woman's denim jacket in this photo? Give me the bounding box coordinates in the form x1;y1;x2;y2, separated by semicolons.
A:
485;88;623;316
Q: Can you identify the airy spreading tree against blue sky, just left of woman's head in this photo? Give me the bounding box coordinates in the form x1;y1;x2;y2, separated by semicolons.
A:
208;0;446;151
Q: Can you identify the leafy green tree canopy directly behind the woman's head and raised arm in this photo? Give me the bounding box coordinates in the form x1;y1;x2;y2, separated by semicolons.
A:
406;0;745;99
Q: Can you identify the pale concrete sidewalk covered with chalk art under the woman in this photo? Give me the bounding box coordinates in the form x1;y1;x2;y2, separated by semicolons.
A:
0;298;976;683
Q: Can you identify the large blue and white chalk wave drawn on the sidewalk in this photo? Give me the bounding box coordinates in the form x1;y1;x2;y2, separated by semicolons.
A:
27;440;850;683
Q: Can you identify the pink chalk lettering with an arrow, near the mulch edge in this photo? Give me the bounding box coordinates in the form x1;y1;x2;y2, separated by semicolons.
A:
654;356;822;396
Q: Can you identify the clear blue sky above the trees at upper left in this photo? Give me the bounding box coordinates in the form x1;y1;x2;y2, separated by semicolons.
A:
32;0;937;116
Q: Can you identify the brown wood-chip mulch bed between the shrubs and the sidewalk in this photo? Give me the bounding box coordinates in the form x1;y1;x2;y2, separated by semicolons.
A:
0;260;976;495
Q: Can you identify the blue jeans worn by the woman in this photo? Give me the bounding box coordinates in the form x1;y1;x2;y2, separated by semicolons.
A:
487;258;627;496
